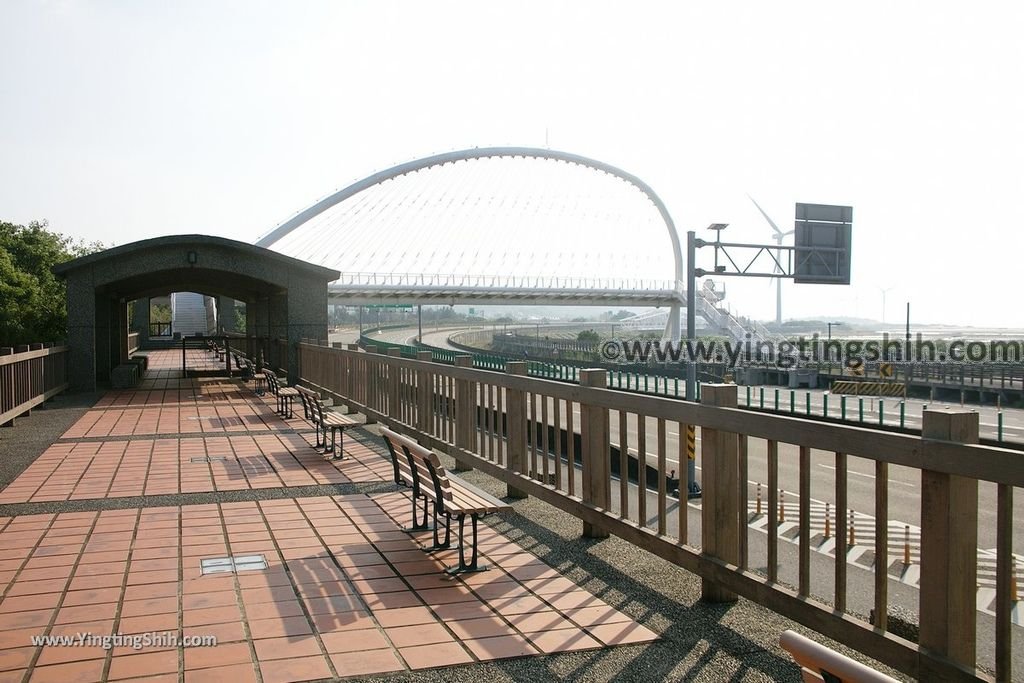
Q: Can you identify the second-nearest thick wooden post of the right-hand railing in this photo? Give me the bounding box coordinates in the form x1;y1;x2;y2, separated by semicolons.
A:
700;384;745;602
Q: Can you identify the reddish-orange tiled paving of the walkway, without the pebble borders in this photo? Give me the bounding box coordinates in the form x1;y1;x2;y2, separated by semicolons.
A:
0;352;656;683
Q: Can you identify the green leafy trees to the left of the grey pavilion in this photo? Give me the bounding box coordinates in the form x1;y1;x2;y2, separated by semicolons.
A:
0;221;103;346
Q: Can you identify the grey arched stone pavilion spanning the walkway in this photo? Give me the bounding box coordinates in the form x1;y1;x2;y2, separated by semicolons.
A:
53;234;339;390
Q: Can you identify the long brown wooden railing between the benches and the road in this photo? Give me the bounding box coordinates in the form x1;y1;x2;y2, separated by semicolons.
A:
299;344;1024;680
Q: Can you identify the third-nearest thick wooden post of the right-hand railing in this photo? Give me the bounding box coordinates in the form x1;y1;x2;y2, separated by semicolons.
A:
585;369;611;539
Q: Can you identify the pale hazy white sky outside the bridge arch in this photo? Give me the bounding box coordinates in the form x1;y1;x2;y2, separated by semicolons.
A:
0;0;1024;327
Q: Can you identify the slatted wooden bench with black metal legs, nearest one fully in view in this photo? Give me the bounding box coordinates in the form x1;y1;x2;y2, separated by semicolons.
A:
382;430;512;574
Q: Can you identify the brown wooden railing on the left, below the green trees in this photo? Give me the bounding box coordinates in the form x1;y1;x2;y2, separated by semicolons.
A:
0;343;68;426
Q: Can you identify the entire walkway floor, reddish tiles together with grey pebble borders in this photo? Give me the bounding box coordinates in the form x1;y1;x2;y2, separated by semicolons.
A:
0;351;851;683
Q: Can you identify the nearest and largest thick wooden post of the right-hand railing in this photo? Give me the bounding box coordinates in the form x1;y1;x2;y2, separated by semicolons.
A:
919;410;978;681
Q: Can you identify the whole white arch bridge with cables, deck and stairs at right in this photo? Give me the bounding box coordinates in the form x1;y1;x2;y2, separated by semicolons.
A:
256;147;768;339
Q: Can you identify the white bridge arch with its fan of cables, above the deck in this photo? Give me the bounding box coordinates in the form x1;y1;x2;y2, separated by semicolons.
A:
256;146;683;305
